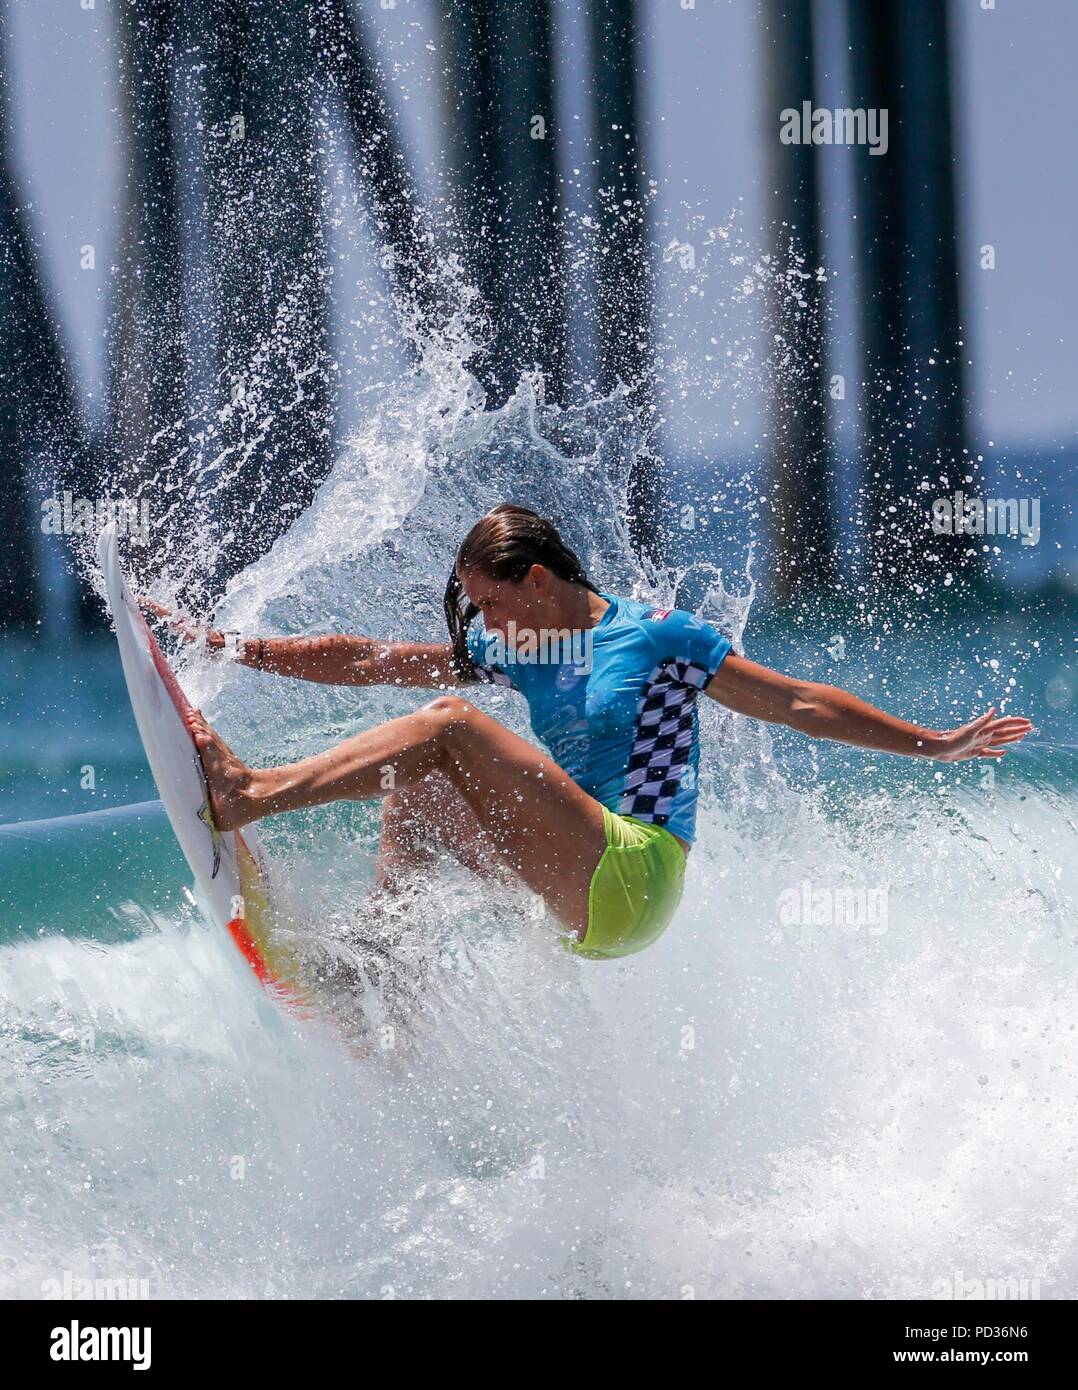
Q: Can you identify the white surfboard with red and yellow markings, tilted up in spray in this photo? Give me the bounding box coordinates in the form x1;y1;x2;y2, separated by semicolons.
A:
97;523;308;1009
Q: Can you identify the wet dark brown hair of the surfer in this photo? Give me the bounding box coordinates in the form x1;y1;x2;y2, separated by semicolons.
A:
445;502;599;681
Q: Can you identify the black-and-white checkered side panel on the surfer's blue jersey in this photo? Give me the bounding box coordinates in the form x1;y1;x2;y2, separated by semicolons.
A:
618;656;714;826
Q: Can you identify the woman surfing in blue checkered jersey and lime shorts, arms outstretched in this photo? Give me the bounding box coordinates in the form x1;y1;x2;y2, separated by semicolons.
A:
150;505;1031;958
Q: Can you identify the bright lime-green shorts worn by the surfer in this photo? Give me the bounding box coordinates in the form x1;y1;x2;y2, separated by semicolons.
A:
567;806;685;960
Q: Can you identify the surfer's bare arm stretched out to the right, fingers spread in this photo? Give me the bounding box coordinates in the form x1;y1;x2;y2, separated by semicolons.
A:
704;653;1032;763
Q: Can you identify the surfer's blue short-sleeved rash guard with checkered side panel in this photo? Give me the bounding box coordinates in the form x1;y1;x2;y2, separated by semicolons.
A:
468;594;731;844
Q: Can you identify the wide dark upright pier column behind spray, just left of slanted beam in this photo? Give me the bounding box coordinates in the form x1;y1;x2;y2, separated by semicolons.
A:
185;0;333;581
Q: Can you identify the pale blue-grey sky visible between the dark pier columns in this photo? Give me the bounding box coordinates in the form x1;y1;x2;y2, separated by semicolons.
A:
8;0;1078;455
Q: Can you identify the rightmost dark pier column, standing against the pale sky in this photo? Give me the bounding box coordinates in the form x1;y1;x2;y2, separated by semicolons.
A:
847;0;979;587
